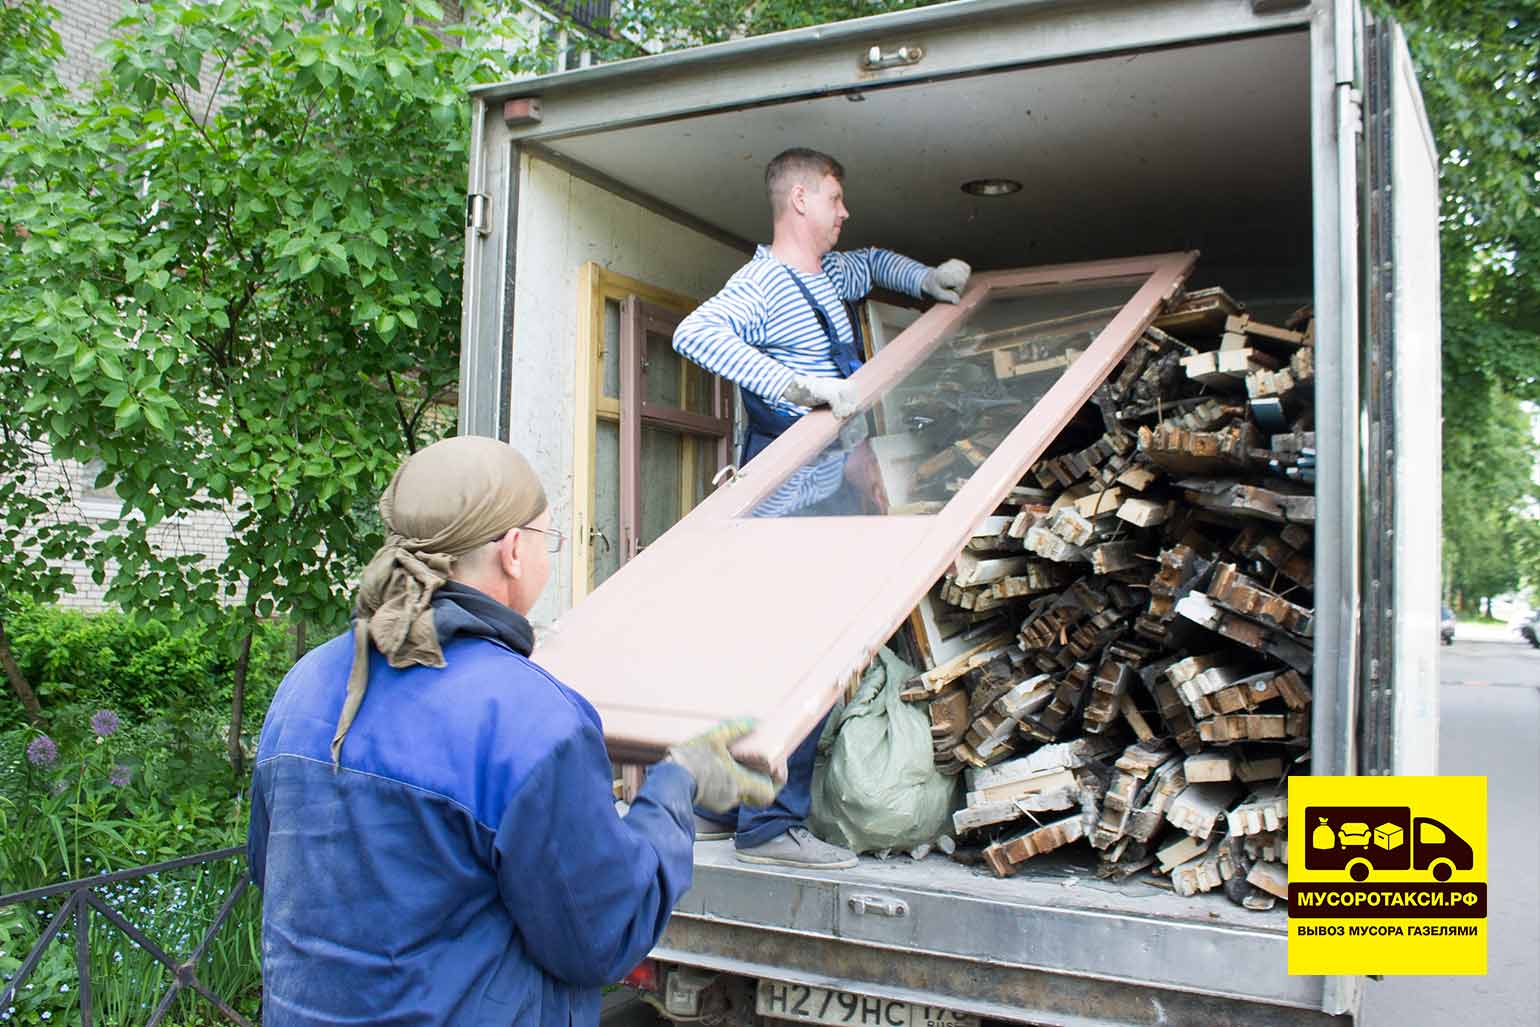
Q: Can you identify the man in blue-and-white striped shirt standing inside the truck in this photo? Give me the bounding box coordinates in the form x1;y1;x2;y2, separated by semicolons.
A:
673;148;970;868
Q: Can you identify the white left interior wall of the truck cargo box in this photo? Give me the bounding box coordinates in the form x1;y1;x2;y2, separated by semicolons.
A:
508;156;744;624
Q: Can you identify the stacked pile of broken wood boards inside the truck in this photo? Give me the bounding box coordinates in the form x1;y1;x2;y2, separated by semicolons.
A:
904;289;1315;908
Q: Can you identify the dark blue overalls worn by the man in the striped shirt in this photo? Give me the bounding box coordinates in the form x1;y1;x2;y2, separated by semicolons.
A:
696;268;861;848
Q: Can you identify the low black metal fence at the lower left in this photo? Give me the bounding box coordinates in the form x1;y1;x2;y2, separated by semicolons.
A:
0;845;253;1027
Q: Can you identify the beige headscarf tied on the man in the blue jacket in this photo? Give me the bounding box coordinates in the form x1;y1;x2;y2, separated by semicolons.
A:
331;436;545;765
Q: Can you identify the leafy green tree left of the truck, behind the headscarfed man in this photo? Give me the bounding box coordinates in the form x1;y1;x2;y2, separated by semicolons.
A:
0;0;539;756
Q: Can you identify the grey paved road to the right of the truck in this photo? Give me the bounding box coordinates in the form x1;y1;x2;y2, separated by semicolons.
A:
1360;630;1540;1027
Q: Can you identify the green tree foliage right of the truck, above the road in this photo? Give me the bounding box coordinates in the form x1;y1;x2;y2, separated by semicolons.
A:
1389;0;1540;599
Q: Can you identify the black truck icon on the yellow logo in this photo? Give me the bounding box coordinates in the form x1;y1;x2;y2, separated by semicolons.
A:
1304;805;1475;881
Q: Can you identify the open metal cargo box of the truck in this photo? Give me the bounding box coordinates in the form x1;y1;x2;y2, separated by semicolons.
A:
460;0;1440;1024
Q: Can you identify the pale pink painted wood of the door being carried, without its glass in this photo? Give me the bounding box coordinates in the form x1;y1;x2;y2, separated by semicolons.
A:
537;253;1197;767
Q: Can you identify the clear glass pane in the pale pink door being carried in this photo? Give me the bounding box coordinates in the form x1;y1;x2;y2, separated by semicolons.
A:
750;274;1147;517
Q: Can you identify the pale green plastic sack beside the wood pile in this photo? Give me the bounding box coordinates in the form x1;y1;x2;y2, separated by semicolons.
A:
809;648;958;853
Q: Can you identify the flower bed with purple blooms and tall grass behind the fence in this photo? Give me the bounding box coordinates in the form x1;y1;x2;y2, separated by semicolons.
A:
0;705;260;1024
